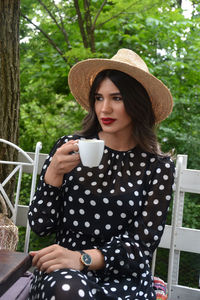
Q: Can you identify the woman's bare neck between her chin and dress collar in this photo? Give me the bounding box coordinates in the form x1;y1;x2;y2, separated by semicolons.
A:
98;131;136;151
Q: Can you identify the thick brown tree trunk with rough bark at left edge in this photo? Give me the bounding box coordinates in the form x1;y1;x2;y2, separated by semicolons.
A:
0;0;20;211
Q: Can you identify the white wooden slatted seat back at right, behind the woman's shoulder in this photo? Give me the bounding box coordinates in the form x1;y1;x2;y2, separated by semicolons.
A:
152;155;200;300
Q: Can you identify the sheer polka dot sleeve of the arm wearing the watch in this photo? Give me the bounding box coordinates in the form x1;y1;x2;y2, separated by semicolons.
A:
100;158;174;277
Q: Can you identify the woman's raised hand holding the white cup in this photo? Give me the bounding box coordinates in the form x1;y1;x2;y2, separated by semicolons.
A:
44;140;80;187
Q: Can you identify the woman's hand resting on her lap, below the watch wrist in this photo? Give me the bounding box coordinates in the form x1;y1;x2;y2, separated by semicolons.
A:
30;244;83;273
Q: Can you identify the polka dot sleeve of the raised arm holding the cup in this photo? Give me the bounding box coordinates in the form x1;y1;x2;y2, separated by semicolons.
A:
28;137;68;236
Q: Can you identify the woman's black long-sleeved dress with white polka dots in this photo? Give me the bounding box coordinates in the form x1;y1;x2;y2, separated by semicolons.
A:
29;135;174;300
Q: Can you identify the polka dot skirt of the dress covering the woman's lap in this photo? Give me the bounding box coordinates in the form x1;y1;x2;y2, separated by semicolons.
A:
29;269;155;300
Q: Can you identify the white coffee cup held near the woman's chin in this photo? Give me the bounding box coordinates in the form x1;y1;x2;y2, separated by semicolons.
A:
78;139;104;168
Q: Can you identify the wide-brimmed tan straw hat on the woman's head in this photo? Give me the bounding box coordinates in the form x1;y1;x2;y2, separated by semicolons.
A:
68;49;173;123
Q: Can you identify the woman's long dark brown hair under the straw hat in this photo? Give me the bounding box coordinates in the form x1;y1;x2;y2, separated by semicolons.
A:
80;70;161;155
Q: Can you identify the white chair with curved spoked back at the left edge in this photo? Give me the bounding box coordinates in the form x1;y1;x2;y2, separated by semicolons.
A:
0;139;42;253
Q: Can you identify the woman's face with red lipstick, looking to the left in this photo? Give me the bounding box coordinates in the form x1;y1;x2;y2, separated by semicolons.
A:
95;78;133;135
